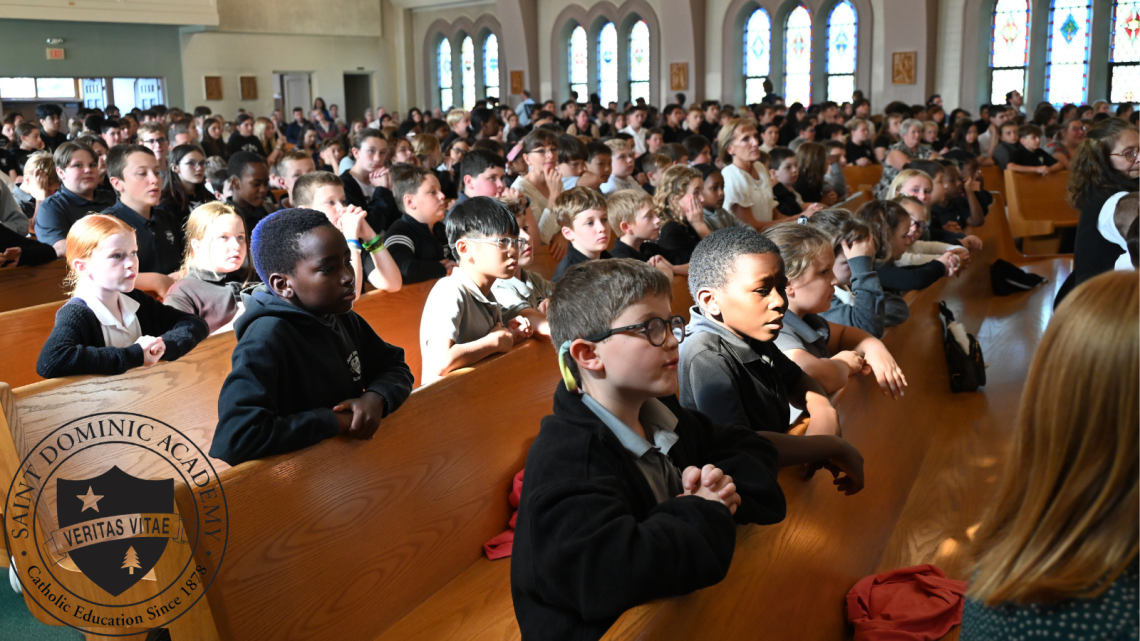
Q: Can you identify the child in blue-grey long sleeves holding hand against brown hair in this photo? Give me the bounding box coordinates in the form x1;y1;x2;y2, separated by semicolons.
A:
808;209;911;339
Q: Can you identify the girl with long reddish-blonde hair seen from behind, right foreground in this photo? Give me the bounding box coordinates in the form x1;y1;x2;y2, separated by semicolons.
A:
961;273;1140;641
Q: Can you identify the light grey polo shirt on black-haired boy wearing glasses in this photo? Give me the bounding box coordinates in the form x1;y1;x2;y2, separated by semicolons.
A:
420;267;503;384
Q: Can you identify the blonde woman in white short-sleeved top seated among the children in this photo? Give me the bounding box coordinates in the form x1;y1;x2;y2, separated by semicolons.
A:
717;119;776;222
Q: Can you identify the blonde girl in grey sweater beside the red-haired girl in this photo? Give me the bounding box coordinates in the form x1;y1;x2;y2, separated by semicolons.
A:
163;203;257;334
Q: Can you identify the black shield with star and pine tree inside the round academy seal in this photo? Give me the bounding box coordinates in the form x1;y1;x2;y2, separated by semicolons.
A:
56;466;174;597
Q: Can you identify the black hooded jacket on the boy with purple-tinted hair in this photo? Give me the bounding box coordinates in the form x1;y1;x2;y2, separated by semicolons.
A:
210;289;412;465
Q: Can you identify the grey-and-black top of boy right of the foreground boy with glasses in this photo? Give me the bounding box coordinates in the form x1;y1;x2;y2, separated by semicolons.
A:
677;306;804;432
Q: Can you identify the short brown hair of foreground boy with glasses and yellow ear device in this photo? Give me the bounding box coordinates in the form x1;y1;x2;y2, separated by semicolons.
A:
547;258;673;379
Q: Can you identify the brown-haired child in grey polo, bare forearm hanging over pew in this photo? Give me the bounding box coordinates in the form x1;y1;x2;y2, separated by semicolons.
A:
764;222;906;403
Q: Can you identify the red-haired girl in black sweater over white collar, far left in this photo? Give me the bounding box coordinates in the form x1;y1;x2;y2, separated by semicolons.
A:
35;214;210;379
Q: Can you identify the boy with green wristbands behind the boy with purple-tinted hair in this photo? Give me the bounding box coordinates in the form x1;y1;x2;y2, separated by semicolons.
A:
293;171;404;298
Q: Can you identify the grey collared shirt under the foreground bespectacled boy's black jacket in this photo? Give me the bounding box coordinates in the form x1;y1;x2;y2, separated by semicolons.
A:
581;393;685;503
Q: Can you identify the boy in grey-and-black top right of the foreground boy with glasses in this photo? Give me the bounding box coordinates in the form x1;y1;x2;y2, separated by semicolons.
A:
678;228;839;435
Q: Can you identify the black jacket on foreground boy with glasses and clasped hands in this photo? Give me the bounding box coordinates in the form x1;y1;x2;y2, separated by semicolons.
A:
511;383;785;641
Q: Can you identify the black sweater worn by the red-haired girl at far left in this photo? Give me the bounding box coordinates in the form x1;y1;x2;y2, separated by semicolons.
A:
35;290;210;379
